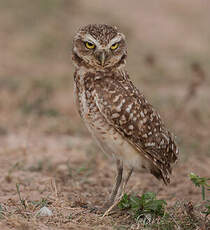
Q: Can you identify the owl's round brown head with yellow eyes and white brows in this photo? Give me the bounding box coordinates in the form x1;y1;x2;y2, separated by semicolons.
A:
73;24;127;70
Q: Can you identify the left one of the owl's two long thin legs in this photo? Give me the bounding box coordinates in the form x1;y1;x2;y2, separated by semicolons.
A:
104;159;123;208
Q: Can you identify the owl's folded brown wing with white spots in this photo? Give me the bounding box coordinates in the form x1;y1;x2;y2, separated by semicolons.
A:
94;73;178;184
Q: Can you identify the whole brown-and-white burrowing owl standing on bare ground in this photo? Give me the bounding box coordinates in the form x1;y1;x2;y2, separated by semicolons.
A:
73;24;178;209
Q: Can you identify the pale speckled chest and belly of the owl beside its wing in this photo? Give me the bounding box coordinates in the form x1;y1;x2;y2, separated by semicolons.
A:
75;69;139;164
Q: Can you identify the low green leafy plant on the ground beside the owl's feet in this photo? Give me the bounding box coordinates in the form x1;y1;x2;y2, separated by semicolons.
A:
118;192;166;222
